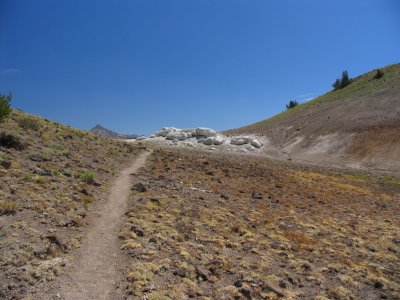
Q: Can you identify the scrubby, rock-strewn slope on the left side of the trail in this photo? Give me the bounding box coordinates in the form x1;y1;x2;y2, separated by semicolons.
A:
0;110;139;299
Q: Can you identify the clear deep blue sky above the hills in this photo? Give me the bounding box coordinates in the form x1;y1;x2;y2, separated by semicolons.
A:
0;0;400;134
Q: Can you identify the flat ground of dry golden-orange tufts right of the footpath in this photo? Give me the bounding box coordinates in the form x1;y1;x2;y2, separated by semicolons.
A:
120;150;400;299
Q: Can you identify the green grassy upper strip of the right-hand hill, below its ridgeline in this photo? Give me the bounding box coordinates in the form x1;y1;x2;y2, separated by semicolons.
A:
227;64;400;134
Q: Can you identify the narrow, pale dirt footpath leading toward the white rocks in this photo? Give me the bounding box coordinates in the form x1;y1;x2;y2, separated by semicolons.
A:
57;151;151;300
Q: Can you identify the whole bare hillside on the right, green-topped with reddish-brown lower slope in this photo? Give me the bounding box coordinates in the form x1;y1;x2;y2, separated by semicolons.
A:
227;64;400;171
